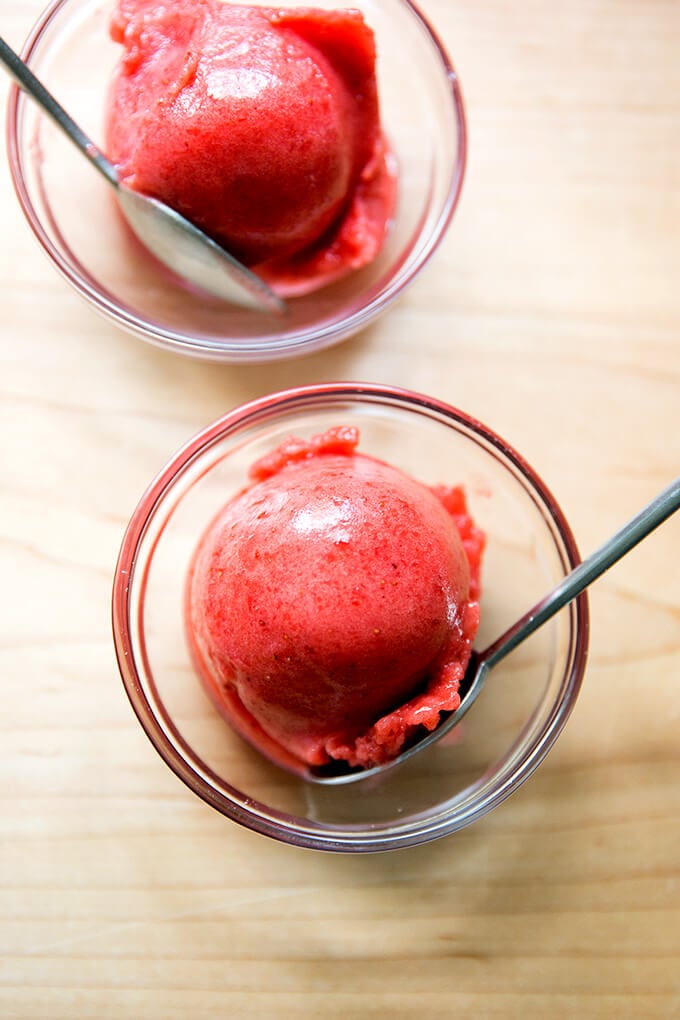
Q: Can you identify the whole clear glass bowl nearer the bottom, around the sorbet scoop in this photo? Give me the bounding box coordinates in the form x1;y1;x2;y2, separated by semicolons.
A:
112;384;588;852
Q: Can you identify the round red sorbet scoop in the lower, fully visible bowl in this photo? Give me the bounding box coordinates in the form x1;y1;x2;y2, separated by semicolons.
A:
187;427;484;769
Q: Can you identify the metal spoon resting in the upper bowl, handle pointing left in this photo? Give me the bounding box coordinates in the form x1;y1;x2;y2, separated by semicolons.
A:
0;38;285;315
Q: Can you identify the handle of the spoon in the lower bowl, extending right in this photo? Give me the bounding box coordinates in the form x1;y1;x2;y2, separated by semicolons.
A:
479;477;680;669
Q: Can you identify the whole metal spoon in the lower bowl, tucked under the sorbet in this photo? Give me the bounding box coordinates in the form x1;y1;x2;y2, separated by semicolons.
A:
304;477;680;785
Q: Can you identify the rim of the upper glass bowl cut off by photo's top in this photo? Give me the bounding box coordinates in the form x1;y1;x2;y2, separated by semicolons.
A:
5;0;468;362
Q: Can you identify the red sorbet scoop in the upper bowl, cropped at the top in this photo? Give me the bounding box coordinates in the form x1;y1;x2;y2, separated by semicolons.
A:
107;0;396;297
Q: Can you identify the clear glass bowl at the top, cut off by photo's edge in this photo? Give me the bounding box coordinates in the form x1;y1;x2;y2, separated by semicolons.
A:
7;0;466;361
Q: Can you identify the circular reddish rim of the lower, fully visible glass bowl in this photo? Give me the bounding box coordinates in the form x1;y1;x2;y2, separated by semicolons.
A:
111;381;589;853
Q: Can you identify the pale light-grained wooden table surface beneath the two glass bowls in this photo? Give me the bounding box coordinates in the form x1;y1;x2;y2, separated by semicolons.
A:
0;0;680;1020
